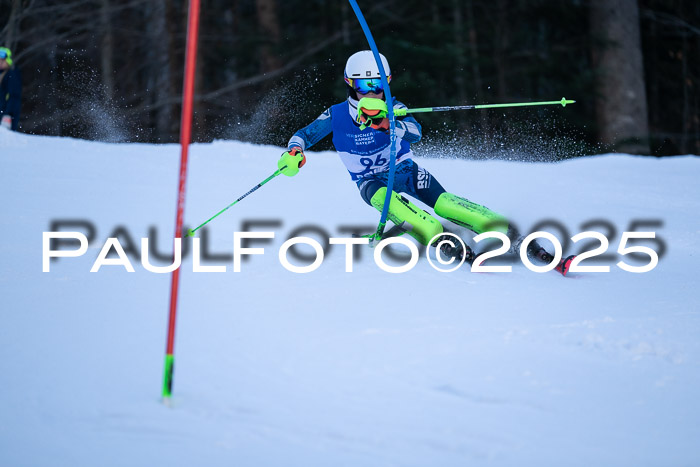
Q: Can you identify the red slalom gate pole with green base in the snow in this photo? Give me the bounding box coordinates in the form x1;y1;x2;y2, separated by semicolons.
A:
163;0;204;404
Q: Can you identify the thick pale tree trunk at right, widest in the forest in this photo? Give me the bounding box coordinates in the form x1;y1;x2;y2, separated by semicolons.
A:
591;0;650;154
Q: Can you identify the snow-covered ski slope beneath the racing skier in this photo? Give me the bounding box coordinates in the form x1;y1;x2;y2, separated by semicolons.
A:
0;131;700;466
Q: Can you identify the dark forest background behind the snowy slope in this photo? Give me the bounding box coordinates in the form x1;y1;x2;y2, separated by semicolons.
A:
0;0;700;160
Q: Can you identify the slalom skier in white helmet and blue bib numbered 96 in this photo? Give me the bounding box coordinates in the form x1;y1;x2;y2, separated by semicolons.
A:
278;50;573;274
